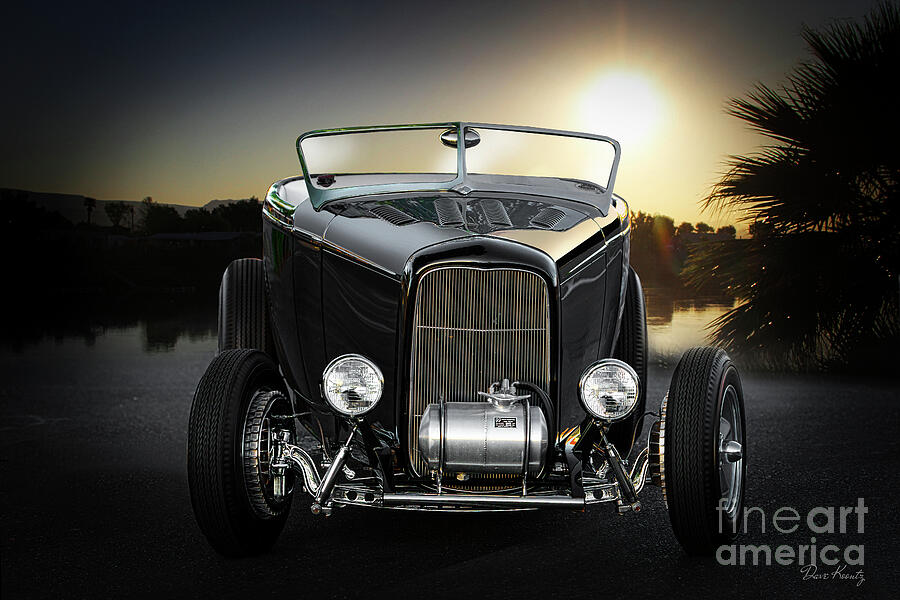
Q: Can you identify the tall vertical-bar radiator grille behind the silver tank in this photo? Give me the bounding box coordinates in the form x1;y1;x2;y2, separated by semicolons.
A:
408;267;550;474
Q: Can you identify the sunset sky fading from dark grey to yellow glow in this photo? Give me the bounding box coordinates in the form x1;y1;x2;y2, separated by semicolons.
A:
0;0;875;223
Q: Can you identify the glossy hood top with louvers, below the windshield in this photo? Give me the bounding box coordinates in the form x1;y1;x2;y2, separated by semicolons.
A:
322;194;603;275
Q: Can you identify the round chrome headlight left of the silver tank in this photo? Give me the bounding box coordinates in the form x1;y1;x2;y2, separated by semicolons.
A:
322;354;384;417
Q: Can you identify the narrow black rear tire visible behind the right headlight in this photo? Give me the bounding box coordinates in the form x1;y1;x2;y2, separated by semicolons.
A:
609;267;647;457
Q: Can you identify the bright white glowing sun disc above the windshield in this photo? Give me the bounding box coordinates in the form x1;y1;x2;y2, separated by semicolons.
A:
580;69;663;147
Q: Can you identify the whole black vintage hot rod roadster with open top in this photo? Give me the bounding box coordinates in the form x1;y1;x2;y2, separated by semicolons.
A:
187;122;746;555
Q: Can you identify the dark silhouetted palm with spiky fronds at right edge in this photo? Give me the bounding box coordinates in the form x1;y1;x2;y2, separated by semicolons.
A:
688;3;900;367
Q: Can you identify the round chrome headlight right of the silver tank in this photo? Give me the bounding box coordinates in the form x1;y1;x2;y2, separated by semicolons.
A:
578;358;640;422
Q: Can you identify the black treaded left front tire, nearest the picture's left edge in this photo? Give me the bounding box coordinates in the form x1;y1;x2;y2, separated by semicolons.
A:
187;349;291;556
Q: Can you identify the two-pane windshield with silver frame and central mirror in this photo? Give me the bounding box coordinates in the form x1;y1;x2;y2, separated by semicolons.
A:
297;123;619;214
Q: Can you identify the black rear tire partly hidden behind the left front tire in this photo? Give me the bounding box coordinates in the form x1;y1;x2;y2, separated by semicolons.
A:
219;258;275;357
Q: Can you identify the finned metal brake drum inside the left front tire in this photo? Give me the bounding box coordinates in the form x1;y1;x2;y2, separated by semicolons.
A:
242;390;294;519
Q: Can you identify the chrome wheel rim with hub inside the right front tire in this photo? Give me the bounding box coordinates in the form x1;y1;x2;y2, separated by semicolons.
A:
716;385;744;519
